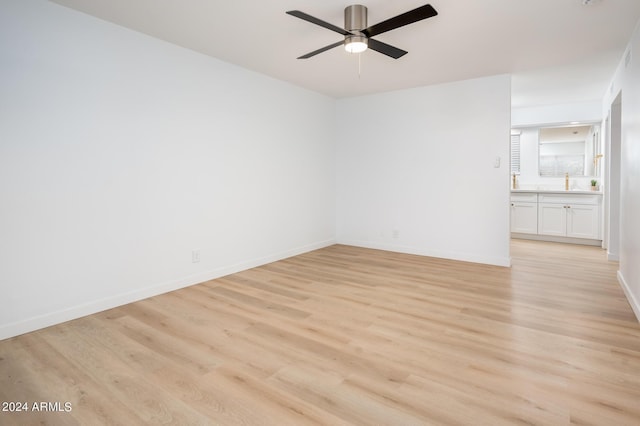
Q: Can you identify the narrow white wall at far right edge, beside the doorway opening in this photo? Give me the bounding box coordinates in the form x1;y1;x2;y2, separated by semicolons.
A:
603;23;640;320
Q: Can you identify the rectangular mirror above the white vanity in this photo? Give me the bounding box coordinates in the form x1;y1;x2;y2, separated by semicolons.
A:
538;124;602;177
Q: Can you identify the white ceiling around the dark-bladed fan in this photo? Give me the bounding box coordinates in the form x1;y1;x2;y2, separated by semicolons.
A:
53;0;640;107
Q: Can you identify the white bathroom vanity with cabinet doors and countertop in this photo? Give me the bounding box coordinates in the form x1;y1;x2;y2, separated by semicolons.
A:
511;189;602;246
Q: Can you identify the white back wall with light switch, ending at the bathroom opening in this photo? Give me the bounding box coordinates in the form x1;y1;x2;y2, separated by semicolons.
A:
337;75;510;265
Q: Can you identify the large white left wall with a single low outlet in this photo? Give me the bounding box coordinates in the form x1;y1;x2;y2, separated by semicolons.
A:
0;0;335;339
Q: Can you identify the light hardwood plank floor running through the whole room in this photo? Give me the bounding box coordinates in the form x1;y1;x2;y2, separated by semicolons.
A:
0;240;640;425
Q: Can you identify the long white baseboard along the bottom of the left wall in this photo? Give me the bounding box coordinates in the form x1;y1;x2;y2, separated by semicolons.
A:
0;239;336;340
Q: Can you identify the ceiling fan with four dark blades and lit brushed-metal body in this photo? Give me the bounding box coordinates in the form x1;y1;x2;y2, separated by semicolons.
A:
287;4;438;59
